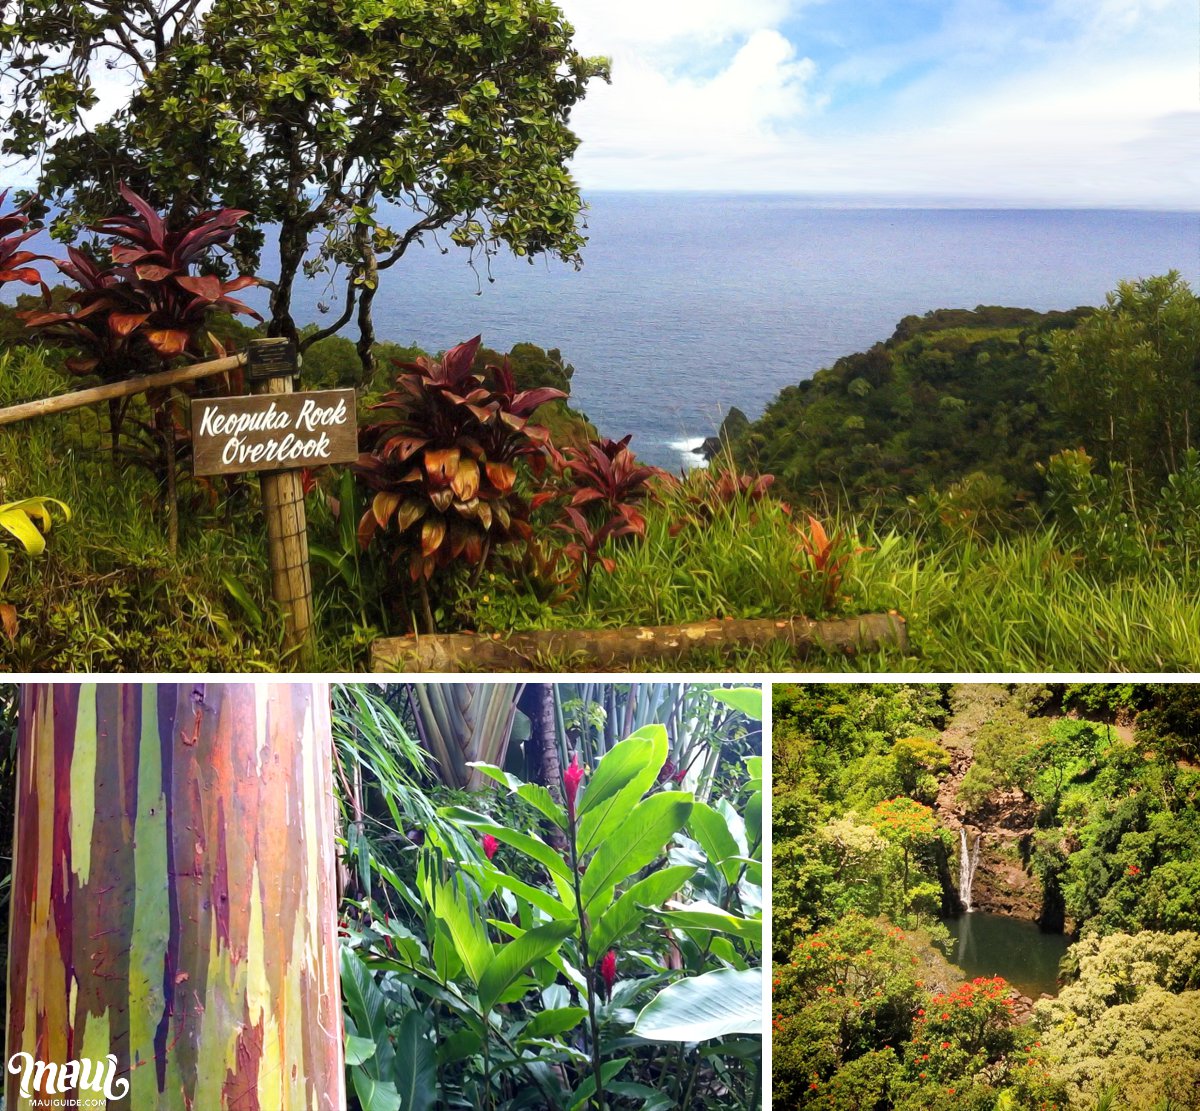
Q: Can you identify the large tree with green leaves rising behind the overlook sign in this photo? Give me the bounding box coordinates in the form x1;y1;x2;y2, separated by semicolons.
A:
0;0;608;367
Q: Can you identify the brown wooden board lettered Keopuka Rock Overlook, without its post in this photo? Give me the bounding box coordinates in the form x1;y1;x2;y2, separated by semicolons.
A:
192;390;359;475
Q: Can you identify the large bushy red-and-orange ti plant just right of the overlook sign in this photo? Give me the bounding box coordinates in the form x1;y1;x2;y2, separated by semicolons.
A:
354;336;566;631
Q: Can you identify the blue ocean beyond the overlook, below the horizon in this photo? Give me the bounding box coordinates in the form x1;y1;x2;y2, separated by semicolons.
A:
283;193;1200;469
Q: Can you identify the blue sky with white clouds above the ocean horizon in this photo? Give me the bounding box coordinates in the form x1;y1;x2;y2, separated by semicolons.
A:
559;0;1200;209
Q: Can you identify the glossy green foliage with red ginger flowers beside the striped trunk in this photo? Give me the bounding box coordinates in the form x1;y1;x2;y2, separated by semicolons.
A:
335;686;763;1111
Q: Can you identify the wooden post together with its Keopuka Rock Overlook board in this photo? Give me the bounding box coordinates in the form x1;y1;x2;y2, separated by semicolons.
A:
192;338;358;668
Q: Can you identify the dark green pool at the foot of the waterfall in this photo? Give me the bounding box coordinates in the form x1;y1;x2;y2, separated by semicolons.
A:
944;911;1069;999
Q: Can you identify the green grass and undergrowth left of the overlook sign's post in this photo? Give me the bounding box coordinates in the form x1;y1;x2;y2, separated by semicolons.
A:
0;348;340;672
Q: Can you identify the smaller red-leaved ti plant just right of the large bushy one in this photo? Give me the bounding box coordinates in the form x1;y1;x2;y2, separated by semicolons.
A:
534;436;673;600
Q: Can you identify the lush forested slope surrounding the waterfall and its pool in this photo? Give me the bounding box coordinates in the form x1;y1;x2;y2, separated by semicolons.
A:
773;684;1200;1111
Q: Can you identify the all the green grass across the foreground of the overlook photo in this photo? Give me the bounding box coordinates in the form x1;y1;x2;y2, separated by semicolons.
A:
0;349;1200;673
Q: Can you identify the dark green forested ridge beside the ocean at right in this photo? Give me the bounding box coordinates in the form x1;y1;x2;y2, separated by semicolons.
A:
730;274;1200;532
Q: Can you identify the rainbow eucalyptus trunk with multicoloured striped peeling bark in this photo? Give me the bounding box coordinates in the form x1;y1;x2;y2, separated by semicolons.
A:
6;683;344;1111
